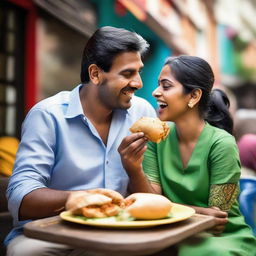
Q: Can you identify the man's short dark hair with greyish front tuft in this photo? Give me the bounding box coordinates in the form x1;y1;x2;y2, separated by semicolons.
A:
80;26;149;83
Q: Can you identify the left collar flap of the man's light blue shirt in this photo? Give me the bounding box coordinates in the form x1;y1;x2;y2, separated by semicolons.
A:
65;84;84;118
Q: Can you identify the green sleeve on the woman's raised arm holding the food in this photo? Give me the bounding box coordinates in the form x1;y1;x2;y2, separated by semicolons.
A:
143;142;160;184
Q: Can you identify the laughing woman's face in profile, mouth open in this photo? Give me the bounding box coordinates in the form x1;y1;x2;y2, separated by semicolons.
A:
152;65;190;122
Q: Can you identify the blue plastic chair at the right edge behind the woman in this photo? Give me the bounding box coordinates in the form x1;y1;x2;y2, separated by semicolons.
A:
239;178;256;235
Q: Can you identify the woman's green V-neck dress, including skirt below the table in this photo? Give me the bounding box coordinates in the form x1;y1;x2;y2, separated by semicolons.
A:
143;123;256;256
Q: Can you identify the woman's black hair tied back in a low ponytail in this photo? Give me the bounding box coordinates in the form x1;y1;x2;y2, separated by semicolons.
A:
164;55;233;134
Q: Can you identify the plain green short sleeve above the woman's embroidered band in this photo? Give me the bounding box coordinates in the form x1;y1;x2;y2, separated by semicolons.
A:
209;135;241;184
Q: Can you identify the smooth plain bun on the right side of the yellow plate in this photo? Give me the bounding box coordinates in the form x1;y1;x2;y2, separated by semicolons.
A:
125;193;172;220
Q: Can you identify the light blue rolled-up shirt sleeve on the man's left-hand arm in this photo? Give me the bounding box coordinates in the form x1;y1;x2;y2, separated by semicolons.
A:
6;108;56;222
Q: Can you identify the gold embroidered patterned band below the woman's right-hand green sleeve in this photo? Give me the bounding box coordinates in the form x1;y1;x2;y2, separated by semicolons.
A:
209;184;239;211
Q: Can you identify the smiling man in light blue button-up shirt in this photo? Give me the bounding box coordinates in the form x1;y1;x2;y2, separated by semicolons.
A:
6;27;155;256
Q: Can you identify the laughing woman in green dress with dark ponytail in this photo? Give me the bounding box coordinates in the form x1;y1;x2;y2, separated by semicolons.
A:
119;56;256;256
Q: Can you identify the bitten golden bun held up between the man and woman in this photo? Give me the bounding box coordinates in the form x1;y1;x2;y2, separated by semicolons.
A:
130;117;170;143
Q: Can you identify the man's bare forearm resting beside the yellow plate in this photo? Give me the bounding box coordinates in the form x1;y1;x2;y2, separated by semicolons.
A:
19;188;70;220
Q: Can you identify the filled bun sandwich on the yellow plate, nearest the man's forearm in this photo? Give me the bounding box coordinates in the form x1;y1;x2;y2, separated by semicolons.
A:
65;188;125;218
